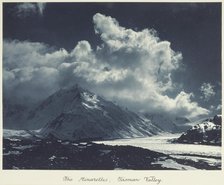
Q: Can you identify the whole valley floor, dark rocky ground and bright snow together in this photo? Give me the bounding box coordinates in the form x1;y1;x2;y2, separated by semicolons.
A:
3;130;221;170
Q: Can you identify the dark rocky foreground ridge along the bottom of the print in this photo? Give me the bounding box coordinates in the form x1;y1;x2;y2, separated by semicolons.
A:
3;139;221;170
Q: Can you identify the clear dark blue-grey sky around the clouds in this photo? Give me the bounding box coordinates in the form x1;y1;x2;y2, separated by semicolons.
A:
3;3;221;118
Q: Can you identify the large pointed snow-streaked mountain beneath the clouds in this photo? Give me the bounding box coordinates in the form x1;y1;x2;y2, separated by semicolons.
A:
14;85;162;140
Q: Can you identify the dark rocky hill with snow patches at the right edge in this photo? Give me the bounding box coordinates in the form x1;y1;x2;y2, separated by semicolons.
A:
177;115;222;145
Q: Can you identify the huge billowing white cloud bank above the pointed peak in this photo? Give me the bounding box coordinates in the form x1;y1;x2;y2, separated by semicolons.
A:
3;13;209;117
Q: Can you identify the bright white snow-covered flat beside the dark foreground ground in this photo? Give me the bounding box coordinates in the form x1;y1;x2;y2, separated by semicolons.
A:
95;134;221;170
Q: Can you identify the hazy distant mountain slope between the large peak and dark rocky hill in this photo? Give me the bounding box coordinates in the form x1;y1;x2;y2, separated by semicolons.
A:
144;113;191;133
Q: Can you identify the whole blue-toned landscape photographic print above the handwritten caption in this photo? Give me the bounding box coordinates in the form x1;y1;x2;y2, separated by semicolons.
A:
2;2;222;171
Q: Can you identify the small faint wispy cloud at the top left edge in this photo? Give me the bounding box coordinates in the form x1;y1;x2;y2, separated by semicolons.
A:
16;3;46;17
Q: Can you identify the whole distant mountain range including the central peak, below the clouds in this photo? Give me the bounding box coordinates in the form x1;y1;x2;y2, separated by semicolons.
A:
3;85;190;140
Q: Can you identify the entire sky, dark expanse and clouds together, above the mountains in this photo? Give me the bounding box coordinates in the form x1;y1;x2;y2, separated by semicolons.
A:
3;3;221;119
